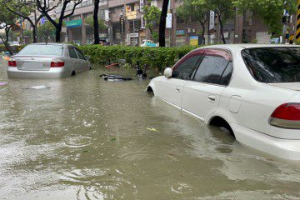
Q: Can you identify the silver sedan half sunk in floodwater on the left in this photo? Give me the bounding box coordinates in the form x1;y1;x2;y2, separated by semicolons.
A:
7;43;91;78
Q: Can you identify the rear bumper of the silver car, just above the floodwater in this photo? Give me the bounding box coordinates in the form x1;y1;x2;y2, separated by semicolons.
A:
7;67;65;79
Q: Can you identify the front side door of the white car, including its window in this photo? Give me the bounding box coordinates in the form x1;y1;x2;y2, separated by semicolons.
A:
157;52;202;108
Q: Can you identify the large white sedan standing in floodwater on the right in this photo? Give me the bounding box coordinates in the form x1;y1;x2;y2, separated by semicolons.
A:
147;44;300;160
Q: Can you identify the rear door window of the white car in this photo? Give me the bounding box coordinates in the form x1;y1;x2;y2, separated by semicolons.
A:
194;56;229;84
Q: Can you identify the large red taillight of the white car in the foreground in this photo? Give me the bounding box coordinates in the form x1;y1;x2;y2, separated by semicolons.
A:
270;103;300;129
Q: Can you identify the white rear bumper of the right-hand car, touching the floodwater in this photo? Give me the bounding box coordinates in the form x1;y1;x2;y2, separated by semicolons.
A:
230;124;300;160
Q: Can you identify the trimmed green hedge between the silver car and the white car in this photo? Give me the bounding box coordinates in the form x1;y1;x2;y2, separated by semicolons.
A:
78;45;195;70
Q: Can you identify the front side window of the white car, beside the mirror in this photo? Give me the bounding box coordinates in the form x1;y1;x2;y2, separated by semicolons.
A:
172;55;202;80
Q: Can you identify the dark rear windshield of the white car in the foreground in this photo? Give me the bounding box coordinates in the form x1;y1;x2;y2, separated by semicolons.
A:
242;47;300;83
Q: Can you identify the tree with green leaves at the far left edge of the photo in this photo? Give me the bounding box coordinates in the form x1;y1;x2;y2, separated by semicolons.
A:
0;1;16;54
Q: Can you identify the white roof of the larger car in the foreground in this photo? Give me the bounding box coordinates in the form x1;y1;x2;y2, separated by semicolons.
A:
198;44;300;51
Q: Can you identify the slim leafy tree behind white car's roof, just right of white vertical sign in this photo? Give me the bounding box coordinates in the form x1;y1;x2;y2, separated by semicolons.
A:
192;0;234;44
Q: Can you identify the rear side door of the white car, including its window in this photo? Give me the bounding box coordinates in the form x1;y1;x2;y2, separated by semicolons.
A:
182;49;232;121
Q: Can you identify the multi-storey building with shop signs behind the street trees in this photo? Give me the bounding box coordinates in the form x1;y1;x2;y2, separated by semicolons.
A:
21;0;298;46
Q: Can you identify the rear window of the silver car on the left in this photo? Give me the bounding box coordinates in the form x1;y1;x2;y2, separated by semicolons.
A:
18;44;63;56
